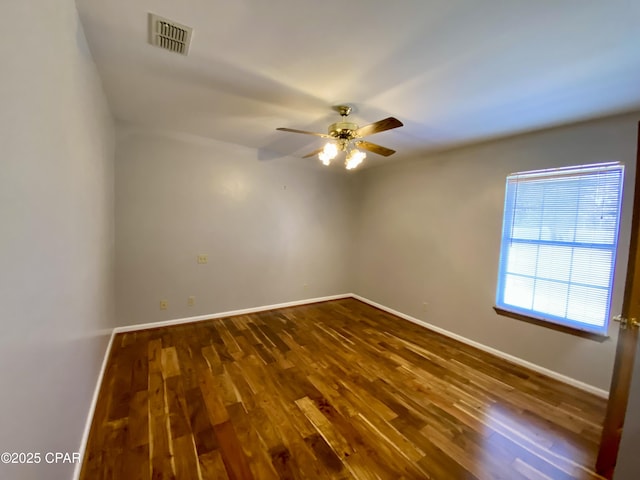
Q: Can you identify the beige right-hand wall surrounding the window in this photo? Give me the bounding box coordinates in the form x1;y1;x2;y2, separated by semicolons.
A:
354;115;640;390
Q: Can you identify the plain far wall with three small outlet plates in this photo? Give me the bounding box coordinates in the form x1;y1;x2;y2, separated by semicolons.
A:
116;126;353;325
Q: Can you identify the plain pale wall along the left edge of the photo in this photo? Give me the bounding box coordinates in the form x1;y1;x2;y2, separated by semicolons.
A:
0;0;114;480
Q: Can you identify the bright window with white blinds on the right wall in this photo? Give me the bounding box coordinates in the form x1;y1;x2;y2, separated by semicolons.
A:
496;163;624;335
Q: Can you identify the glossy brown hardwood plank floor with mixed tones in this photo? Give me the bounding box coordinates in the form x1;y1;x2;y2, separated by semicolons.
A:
81;299;605;480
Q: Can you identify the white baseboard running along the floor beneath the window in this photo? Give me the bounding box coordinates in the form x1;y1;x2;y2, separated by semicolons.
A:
351;294;609;399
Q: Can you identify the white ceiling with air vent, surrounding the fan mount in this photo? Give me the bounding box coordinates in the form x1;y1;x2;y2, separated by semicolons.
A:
77;0;640;169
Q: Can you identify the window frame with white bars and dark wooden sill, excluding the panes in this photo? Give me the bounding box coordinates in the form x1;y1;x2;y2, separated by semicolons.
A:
493;162;625;341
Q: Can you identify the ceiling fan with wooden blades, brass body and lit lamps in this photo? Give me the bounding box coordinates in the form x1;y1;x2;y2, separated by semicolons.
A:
276;105;402;170
